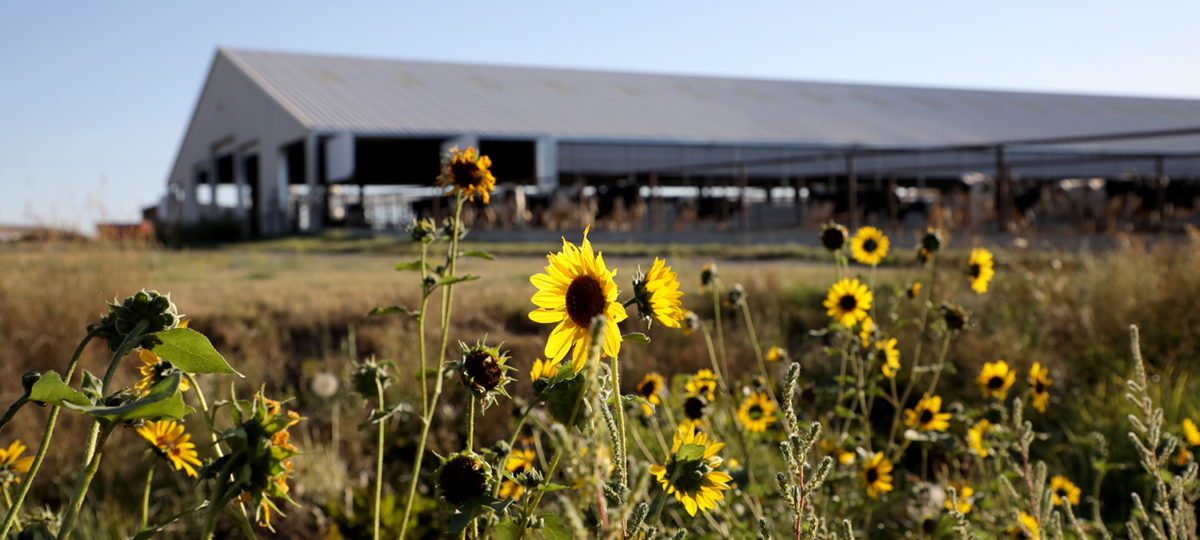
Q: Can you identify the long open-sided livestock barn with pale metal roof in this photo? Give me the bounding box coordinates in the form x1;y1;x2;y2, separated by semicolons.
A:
164;48;1200;236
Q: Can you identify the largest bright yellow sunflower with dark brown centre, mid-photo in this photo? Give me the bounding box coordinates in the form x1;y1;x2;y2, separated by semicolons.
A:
529;230;626;373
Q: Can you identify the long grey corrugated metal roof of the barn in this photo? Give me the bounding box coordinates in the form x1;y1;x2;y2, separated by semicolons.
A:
218;49;1200;151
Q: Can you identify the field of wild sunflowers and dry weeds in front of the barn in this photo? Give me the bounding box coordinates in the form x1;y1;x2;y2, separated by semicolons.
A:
0;149;1200;540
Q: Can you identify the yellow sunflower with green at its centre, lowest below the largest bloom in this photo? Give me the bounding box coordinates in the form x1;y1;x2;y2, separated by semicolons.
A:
650;422;733;516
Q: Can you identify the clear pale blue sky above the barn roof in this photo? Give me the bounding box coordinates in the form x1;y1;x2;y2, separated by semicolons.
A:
0;0;1200;230
